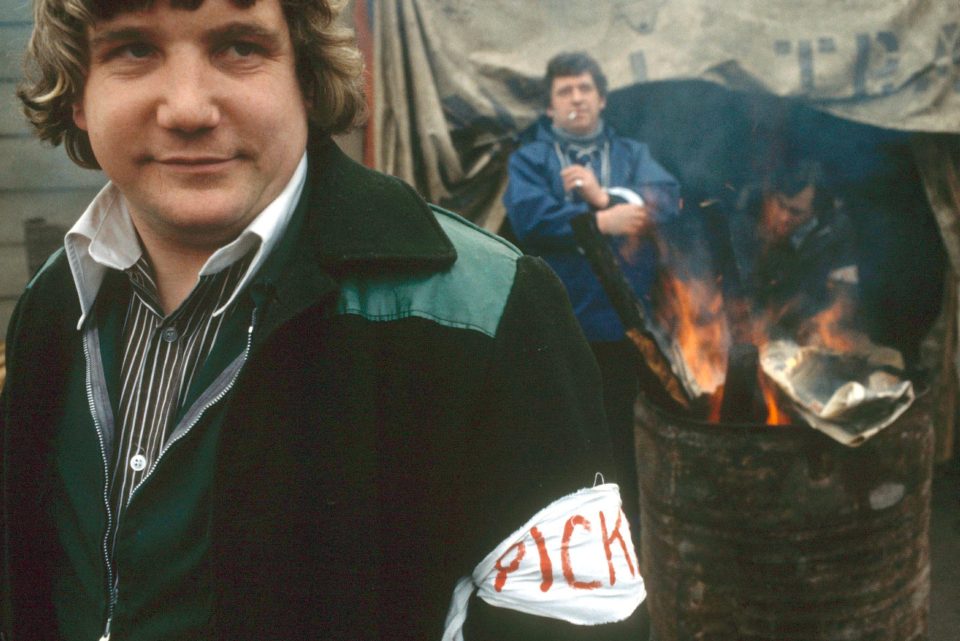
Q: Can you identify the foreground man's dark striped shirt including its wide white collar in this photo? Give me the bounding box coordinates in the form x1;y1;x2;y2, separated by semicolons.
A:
64;152;307;556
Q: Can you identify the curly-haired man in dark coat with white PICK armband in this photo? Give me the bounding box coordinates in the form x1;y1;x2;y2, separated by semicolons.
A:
0;0;644;641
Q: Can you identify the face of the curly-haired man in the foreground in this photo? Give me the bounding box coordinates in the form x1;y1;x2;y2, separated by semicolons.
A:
73;0;307;250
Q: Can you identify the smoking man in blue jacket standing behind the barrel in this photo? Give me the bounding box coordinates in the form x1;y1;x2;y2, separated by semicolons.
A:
503;52;679;519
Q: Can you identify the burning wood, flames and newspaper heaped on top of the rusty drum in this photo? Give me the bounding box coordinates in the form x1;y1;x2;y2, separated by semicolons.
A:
573;190;914;446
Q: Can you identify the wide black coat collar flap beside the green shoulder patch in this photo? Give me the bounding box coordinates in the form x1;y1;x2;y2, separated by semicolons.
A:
250;138;457;343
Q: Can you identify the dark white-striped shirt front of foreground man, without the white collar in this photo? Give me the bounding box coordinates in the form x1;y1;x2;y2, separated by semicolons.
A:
110;250;256;532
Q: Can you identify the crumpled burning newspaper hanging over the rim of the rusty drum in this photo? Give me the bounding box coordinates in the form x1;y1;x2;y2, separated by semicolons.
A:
760;340;914;447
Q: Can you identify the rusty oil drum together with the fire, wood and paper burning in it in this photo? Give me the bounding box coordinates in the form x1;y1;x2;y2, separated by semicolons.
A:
578;158;933;641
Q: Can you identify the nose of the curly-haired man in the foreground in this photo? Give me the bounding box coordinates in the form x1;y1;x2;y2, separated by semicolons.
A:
157;56;220;133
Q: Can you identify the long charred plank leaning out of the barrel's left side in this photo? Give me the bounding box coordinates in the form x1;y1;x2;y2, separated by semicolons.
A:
570;213;691;409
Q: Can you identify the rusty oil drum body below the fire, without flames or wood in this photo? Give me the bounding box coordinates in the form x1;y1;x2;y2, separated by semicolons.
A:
636;395;933;641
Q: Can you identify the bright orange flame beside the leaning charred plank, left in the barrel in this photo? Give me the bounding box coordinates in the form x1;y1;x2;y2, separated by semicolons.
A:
663;276;730;398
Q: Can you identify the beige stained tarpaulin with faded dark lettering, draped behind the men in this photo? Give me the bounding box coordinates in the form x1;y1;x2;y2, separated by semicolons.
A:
373;0;960;222
